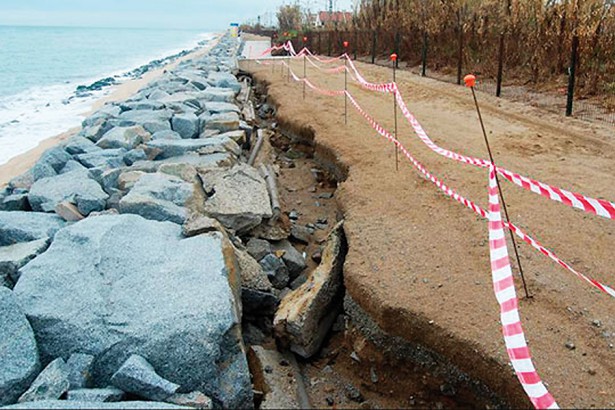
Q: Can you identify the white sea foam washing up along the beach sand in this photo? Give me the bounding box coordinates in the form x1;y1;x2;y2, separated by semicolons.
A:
0;33;214;165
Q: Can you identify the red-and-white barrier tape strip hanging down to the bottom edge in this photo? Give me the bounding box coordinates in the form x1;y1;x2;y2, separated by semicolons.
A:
489;165;559;409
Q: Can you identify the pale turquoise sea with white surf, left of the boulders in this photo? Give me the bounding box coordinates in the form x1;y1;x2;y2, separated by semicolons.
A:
0;25;216;165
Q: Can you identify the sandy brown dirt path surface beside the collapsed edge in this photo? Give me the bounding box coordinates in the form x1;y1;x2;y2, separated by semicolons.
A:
242;50;615;408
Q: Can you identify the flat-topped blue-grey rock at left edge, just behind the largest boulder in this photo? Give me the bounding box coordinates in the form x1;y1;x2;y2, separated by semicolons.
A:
0;211;66;246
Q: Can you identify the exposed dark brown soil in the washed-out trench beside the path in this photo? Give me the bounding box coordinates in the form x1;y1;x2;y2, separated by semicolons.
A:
256;78;503;408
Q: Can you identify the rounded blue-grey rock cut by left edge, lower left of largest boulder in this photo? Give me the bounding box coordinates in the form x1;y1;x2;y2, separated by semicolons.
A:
0;286;40;405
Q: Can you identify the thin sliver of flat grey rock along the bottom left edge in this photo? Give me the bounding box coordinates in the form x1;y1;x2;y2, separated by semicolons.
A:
3;400;192;410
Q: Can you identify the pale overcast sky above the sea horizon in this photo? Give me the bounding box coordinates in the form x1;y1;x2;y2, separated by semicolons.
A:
0;0;353;31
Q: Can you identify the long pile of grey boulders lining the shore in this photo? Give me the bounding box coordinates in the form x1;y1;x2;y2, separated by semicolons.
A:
0;36;316;408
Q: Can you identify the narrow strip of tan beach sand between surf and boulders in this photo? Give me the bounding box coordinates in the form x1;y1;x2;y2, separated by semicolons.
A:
0;33;222;188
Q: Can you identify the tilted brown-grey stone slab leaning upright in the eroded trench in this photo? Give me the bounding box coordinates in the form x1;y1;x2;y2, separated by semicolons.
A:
274;222;347;358
